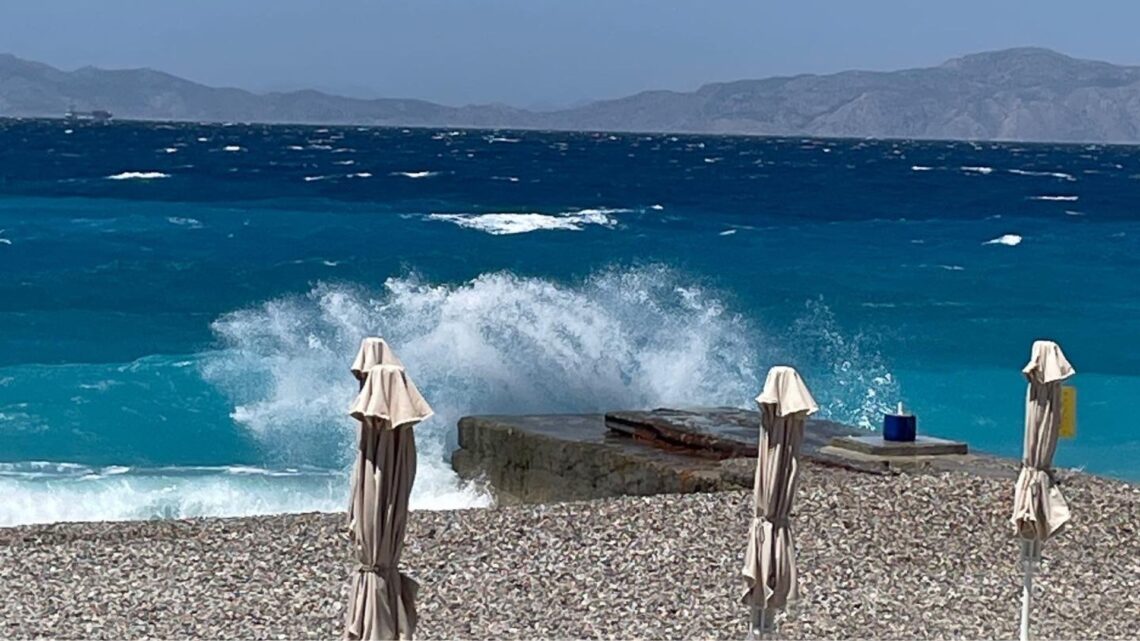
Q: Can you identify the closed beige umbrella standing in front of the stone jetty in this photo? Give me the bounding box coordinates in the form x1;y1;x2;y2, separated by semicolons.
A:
741;367;819;633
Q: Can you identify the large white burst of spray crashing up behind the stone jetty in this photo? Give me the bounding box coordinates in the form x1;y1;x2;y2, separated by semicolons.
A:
203;267;758;508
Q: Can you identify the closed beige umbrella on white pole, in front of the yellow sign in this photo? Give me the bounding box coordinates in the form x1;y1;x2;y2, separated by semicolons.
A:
1010;341;1076;641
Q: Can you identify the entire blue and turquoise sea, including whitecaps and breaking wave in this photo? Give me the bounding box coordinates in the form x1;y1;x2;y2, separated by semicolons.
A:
0;121;1140;525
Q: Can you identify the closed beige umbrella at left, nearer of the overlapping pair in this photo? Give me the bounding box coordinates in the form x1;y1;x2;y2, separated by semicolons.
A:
344;365;432;640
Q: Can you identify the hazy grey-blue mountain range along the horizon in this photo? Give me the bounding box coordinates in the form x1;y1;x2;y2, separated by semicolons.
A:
0;48;1140;143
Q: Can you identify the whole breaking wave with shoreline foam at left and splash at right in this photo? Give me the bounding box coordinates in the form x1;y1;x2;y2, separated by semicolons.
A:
0;266;898;525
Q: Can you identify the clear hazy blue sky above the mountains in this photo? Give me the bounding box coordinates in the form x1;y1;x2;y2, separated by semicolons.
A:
0;0;1140;106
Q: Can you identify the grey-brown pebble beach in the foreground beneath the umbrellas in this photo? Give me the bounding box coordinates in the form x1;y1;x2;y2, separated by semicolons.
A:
0;463;1140;639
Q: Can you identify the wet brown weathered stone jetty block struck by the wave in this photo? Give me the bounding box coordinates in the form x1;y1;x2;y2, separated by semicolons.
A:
451;407;880;504
